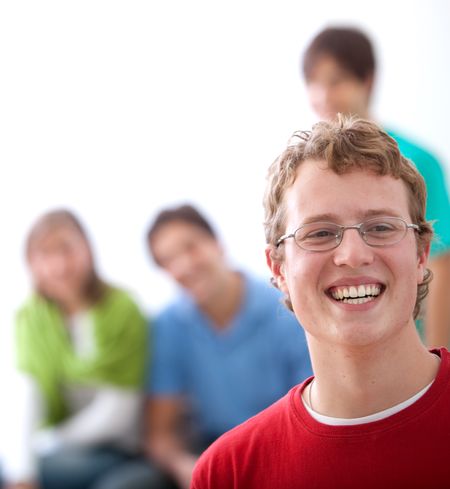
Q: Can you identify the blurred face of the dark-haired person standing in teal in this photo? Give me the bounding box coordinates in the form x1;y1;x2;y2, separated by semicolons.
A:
306;55;372;120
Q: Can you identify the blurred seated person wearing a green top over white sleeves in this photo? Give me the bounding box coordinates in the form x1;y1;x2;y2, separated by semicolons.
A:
3;210;154;489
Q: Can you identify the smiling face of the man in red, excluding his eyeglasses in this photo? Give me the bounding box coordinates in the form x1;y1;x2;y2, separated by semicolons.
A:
271;161;427;346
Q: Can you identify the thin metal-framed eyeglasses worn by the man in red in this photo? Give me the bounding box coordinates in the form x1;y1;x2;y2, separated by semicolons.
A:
276;217;419;251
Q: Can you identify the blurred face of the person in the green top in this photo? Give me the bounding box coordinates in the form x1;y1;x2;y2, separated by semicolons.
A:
29;226;93;306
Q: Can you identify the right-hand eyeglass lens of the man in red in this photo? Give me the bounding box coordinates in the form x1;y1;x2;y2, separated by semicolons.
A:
360;217;408;246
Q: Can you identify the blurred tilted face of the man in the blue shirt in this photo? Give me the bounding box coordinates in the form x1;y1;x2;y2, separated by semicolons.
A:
151;221;226;305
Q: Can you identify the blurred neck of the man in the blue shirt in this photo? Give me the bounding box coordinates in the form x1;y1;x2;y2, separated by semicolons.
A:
200;270;244;329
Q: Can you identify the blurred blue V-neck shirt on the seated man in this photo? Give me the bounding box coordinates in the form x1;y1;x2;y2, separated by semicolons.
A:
148;276;312;438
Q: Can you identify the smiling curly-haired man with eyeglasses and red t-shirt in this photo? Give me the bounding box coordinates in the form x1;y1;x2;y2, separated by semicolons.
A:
192;118;450;489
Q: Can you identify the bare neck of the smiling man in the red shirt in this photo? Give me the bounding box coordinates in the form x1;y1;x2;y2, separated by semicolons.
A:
305;324;439;418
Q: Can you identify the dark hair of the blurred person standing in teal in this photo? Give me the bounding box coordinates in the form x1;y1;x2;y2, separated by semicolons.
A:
303;27;376;81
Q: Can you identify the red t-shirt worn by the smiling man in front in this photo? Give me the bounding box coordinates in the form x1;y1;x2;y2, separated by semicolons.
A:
191;349;450;489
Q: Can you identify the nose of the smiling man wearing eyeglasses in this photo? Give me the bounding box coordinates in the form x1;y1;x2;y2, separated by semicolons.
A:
333;228;375;268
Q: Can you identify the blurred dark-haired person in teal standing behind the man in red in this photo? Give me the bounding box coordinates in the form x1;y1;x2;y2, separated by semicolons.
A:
302;27;450;346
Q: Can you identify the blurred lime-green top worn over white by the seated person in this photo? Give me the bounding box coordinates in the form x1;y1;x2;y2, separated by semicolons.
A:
16;287;147;425
